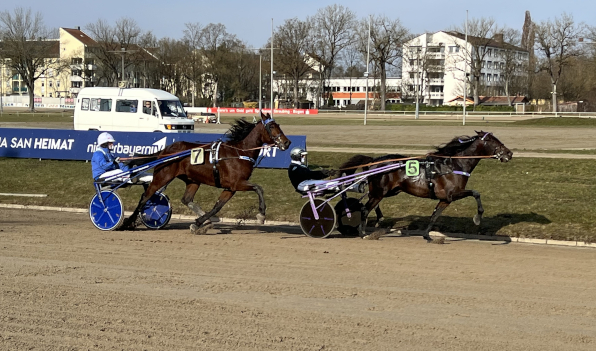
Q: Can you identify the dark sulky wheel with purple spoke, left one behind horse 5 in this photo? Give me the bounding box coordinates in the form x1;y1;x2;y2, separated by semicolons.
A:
300;199;337;238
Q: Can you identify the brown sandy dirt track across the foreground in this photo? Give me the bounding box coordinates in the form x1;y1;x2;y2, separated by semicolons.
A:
0;209;596;350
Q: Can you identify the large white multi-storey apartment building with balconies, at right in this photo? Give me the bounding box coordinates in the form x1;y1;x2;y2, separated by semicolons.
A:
402;31;529;106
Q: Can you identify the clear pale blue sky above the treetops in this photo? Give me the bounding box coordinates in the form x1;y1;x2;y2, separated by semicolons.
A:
0;0;596;47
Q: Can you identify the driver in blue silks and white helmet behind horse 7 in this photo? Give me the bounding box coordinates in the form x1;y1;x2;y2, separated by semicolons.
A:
91;132;128;180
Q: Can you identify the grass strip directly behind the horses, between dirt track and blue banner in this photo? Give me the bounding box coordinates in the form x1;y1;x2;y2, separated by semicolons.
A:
0;152;596;242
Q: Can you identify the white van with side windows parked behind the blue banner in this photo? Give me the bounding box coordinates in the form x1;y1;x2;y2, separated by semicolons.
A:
74;87;194;133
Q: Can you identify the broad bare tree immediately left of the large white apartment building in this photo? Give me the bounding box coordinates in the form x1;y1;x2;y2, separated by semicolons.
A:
355;16;411;111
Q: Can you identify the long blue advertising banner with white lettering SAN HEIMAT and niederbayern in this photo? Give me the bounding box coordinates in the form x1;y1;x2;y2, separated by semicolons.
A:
0;128;306;168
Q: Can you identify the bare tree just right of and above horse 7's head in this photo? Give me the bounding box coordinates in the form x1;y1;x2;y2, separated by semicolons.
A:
274;18;314;107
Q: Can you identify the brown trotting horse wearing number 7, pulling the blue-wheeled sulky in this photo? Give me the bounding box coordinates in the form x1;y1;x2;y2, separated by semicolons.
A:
124;112;291;234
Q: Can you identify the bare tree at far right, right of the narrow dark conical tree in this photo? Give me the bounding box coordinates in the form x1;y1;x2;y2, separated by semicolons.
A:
536;13;584;112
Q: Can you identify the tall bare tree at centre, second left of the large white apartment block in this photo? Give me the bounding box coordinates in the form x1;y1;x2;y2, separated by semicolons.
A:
307;4;356;106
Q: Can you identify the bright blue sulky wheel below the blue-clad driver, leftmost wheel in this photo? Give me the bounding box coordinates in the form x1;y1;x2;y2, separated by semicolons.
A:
89;190;124;230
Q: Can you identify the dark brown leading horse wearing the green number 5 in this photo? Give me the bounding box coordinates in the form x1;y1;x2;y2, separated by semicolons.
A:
340;131;513;241
